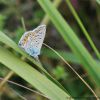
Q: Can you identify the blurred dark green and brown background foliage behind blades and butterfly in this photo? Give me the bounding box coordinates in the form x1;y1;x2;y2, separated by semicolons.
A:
0;0;100;100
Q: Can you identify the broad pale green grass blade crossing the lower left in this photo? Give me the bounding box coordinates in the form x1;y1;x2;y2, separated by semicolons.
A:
0;47;70;100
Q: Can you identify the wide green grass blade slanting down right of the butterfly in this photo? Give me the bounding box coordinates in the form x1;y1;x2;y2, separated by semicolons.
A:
38;0;100;86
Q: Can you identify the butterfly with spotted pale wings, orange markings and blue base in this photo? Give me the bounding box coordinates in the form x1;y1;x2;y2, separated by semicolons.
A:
18;25;46;58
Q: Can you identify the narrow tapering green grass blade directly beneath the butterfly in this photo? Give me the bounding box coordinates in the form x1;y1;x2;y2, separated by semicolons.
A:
0;32;67;93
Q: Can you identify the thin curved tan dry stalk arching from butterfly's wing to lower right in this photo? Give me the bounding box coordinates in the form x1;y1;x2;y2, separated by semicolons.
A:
43;43;99;100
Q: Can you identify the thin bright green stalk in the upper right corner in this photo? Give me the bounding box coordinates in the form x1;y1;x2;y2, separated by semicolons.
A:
66;0;100;59
